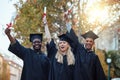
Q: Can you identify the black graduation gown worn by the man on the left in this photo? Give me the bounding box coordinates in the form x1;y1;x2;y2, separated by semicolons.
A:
8;41;50;80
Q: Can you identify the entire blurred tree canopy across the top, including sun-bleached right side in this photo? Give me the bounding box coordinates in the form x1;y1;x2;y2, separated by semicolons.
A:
14;0;120;46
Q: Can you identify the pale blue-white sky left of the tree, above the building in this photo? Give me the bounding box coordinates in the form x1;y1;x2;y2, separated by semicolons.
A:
0;0;21;64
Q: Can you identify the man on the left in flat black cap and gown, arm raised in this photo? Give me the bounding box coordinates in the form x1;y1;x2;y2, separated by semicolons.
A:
5;28;50;80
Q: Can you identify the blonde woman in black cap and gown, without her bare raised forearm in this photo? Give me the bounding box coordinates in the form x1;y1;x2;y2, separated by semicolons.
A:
47;34;75;80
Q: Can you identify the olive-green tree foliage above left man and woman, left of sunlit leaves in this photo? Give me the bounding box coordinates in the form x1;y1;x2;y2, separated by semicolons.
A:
14;0;73;46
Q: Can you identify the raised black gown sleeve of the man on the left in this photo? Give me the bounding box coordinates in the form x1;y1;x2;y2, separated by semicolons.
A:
8;40;28;60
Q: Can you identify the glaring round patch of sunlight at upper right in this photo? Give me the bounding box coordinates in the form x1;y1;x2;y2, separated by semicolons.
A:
85;1;109;24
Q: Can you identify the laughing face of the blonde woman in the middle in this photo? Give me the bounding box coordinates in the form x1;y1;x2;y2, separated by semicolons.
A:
58;41;69;53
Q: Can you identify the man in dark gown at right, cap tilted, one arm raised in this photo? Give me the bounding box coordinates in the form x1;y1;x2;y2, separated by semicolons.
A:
66;22;106;80
